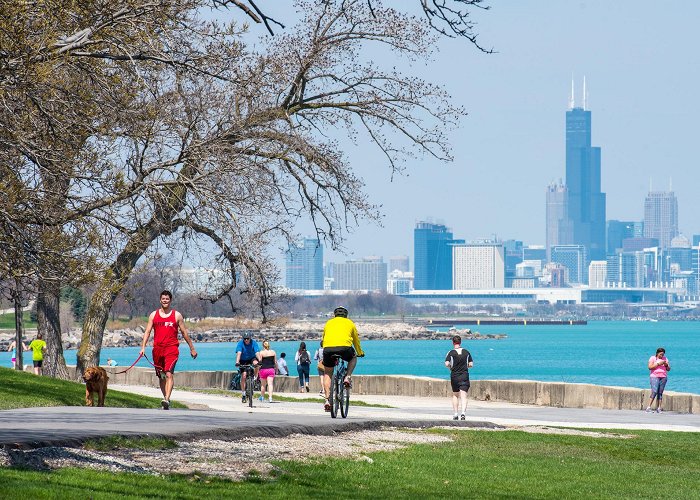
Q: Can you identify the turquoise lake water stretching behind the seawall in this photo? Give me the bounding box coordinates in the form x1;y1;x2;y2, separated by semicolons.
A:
0;321;700;394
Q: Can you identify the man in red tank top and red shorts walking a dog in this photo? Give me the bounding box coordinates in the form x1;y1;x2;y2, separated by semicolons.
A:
140;290;197;410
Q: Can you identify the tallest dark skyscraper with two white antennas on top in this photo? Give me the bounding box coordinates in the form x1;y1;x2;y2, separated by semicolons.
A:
565;79;606;260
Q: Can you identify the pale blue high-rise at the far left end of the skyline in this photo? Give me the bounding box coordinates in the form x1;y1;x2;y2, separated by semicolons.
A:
285;238;324;290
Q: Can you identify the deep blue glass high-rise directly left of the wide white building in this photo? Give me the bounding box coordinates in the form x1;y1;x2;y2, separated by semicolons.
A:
413;222;464;290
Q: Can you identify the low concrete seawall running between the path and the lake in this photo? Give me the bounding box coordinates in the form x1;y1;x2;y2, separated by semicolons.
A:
75;366;700;414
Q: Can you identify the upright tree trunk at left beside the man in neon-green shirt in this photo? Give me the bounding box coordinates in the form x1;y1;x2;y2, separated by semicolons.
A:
36;279;68;379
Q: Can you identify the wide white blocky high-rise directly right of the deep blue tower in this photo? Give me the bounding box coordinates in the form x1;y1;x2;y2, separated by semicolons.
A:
452;242;506;290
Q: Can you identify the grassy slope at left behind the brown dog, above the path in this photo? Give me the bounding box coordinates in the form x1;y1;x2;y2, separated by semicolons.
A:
0;368;186;410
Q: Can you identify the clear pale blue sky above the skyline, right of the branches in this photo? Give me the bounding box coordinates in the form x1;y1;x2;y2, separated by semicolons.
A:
253;0;700;261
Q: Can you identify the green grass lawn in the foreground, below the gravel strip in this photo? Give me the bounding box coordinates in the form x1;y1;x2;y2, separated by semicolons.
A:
0;429;700;499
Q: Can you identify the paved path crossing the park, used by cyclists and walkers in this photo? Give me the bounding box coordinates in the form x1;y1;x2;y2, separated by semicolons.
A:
0;385;700;448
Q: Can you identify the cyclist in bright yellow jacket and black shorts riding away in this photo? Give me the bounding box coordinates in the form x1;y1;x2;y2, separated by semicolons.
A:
323;306;365;411
